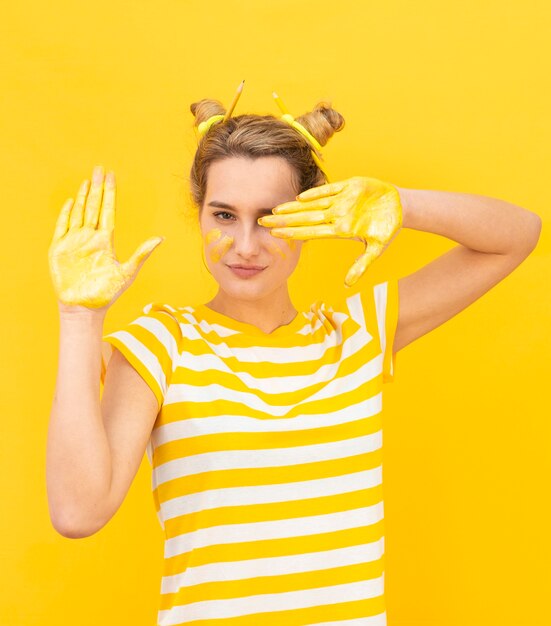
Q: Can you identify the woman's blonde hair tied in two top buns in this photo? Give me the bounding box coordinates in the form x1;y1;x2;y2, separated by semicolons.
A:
190;99;344;212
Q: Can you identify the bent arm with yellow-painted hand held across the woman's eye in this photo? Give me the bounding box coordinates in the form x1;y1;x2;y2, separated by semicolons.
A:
258;176;541;352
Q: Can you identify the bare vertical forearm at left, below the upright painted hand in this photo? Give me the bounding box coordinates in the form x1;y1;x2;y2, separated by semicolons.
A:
46;314;111;536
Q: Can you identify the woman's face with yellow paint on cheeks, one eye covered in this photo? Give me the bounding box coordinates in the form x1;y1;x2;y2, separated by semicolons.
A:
200;156;303;300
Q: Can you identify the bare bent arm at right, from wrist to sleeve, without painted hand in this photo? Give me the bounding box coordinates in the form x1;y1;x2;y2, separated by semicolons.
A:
394;188;542;352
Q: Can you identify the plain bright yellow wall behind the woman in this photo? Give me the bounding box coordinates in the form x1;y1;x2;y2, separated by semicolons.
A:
0;0;551;626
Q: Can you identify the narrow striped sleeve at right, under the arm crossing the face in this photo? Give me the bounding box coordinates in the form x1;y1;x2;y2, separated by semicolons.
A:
373;278;399;383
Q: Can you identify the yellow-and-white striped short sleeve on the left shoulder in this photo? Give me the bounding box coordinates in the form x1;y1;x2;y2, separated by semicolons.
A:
101;302;181;408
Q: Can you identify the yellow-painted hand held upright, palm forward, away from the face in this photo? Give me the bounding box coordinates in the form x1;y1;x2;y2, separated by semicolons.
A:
48;166;163;311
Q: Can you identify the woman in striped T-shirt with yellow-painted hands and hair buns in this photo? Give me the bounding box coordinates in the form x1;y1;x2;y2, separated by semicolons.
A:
47;92;541;626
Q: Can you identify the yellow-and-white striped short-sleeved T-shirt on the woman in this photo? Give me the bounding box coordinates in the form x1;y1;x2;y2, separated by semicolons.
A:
102;280;398;626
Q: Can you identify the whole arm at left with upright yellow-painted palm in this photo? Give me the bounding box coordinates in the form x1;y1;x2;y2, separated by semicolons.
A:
46;168;161;538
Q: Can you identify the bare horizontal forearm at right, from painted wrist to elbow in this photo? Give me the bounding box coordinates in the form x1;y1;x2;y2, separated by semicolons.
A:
398;188;541;254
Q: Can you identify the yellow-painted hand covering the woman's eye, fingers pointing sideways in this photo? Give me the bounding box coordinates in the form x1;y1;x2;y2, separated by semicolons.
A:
258;176;403;287
